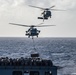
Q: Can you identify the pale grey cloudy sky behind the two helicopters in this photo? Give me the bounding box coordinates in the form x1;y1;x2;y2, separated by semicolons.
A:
0;0;76;37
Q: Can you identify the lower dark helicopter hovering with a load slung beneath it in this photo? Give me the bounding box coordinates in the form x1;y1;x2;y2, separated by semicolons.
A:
9;23;55;39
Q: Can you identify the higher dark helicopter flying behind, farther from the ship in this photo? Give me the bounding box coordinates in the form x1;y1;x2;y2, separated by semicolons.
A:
29;5;64;21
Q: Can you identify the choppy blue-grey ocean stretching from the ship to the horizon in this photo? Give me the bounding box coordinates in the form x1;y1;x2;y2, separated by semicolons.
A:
0;37;76;75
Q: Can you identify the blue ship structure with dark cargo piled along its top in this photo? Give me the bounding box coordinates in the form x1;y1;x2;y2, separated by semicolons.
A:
0;54;57;75
